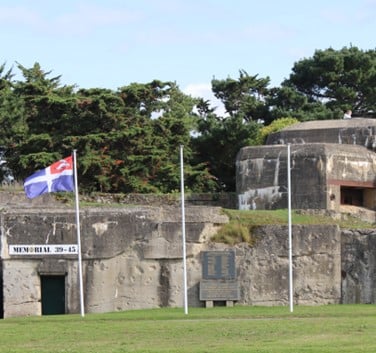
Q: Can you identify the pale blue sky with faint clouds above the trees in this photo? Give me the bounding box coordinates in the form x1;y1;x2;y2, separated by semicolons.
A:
0;0;376;104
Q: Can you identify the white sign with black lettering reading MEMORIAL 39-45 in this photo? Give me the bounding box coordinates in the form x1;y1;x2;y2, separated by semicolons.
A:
9;244;78;255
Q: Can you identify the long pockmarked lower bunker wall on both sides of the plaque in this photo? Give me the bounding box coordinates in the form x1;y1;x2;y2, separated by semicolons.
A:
1;207;341;317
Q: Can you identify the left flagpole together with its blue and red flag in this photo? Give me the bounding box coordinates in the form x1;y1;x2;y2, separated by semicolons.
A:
24;150;85;317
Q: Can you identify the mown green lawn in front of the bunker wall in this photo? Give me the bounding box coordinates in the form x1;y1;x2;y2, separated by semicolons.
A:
0;305;376;353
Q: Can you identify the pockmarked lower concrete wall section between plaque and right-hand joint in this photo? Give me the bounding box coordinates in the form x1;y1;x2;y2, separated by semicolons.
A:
237;226;341;305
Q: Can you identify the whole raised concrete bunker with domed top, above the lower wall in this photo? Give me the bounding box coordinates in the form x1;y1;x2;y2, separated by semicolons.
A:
236;118;376;211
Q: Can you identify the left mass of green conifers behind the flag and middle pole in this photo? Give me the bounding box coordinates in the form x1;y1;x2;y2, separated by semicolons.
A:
0;64;213;193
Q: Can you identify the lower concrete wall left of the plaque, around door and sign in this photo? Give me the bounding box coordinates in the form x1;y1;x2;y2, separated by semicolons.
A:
1;206;227;317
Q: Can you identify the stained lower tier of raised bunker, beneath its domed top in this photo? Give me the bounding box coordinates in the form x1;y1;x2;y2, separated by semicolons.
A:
236;143;376;211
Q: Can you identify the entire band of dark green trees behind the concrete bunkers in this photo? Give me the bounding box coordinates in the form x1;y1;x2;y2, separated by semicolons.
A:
0;47;376;193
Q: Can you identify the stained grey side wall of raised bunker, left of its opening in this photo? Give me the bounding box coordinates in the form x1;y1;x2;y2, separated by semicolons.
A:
236;144;327;210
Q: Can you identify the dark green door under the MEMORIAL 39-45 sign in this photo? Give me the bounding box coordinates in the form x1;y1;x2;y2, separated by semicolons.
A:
40;276;65;315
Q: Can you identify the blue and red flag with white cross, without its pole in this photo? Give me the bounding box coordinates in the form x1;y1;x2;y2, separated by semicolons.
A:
24;156;74;199
